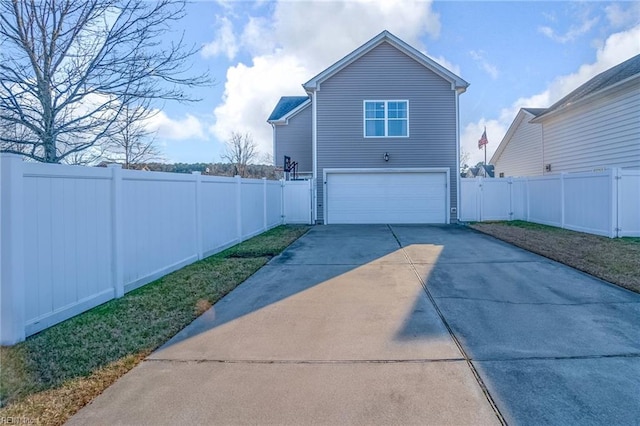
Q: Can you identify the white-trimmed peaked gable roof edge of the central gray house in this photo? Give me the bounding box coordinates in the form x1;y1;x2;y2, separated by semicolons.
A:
302;30;469;93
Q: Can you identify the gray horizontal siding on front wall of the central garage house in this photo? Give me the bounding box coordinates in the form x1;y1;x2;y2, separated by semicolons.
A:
316;43;458;222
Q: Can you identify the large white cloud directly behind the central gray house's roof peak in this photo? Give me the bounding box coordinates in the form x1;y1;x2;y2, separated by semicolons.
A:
209;0;448;158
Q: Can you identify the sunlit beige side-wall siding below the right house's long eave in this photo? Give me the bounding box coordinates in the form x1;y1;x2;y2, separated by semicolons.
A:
542;80;640;173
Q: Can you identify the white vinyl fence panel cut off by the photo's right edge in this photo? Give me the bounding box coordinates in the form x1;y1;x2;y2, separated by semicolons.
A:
617;170;640;237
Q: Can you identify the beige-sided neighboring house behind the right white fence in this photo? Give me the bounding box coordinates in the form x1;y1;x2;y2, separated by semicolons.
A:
491;55;640;176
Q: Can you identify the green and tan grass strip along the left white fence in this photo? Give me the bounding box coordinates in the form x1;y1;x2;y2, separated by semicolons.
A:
0;225;309;425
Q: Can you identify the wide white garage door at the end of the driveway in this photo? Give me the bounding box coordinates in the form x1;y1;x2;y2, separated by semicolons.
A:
325;171;447;224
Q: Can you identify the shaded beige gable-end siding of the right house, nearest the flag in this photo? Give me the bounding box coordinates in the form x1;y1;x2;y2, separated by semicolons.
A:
494;114;544;177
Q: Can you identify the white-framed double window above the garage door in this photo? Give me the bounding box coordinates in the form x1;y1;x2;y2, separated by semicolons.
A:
364;101;409;138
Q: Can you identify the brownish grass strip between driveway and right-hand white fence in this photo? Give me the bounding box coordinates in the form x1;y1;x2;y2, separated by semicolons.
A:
469;221;640;293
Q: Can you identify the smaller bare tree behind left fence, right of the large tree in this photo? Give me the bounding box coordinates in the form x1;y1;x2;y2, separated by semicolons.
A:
101;106;161;169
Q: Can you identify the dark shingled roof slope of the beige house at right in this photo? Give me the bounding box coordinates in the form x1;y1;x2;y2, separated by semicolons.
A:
536;55;640;122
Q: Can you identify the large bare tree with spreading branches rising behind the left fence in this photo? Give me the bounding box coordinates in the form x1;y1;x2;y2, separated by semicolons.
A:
0;0;210;163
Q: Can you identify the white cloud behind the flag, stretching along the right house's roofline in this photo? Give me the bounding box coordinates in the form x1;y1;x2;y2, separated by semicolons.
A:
460;25;640;164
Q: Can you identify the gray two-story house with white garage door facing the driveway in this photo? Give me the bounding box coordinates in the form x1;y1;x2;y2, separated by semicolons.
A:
268;31;469;224
